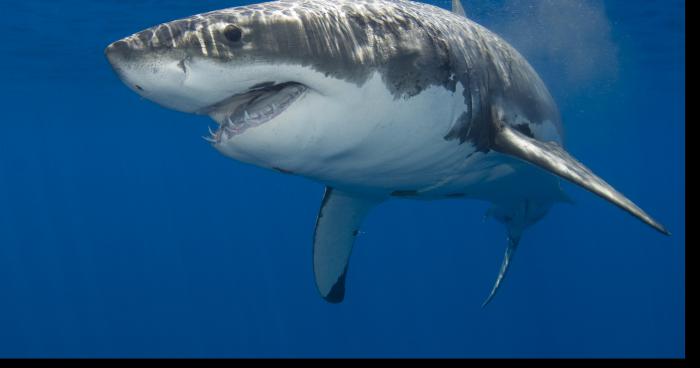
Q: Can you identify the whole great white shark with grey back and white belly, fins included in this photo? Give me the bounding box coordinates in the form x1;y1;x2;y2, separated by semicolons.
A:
105;0;670;304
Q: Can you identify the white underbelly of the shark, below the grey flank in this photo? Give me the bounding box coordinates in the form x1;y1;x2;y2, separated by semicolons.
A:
213;70;562;202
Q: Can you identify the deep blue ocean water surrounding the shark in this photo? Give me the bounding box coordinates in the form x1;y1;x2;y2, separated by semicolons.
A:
0;0;685;358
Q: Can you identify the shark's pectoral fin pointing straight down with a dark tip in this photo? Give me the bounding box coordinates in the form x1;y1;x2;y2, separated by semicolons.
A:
313;188;382;303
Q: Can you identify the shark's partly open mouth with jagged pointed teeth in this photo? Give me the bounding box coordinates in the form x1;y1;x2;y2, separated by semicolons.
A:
205;82;309;143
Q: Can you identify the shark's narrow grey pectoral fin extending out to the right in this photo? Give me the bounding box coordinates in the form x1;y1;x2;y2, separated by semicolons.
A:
491;119;671;235
